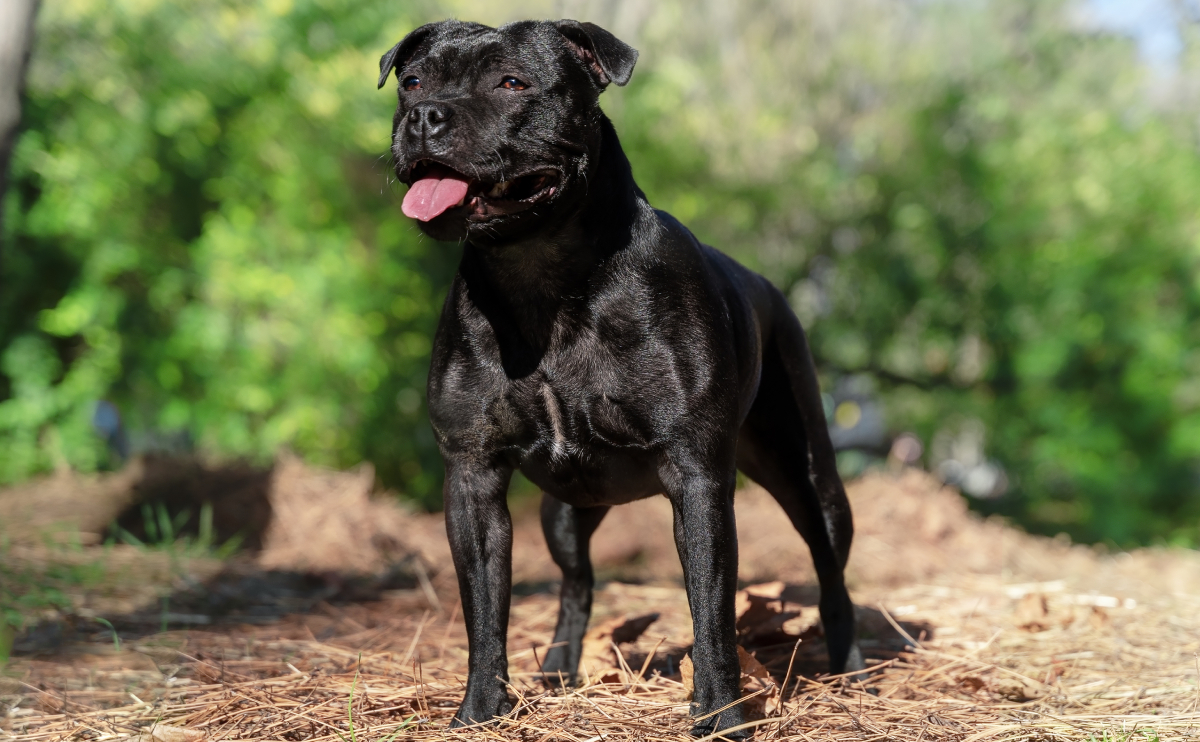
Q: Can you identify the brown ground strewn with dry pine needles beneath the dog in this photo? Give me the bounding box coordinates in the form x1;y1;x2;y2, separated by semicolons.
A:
0;459;1200;742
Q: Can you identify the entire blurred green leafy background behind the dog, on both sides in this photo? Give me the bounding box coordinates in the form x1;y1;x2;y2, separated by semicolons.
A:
0;0;1200;547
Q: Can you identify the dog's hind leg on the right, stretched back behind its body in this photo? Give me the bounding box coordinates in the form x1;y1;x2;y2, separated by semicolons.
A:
738;293;863;674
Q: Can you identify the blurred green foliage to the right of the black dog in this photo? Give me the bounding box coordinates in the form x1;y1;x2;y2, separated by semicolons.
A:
604;1;1200;545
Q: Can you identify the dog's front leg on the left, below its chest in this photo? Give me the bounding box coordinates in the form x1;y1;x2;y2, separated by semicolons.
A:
445;456;512;728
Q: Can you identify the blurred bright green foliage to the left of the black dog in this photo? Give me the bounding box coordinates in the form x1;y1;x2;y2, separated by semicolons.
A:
0;0;455;497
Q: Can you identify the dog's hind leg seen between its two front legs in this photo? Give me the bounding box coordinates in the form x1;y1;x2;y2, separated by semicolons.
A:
541;495;608;684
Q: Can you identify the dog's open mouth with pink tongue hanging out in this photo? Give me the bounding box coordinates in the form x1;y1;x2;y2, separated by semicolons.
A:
401;160;559;222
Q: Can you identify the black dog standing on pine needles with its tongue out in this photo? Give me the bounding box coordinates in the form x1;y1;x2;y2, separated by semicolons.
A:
379;20;862;736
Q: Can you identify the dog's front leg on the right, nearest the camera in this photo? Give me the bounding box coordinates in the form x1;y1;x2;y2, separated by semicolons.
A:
667;462;749;738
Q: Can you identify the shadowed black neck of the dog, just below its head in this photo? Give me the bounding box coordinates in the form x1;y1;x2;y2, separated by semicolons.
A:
458;115;646;378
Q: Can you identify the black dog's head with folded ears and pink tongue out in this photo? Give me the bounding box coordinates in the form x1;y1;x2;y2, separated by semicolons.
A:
379;20;637;243
